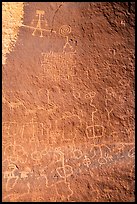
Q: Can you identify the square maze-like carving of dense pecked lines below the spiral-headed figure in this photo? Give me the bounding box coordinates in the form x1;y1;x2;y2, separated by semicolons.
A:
41;52;76;82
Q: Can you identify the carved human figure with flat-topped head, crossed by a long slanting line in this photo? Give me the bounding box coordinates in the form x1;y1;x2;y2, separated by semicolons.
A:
22;10;56;38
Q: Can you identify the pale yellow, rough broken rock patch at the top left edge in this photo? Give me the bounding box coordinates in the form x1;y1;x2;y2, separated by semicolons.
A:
2;2;24;64
